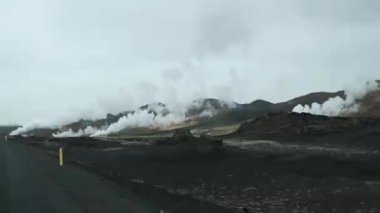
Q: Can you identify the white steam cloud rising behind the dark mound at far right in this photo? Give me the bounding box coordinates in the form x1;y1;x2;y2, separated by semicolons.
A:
292;81;380;116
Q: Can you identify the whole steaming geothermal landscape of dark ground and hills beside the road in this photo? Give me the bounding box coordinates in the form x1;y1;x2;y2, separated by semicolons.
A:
4;81;380;212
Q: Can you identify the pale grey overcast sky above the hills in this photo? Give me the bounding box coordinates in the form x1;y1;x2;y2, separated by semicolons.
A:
0;0;380;124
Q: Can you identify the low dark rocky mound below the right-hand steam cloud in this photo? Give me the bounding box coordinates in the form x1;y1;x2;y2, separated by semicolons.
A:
230;112;380;148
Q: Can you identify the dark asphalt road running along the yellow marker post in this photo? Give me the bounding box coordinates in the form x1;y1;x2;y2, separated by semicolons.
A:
0;138;231;213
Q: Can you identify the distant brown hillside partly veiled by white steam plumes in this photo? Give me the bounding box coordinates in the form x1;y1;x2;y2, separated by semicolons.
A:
14;91;364;136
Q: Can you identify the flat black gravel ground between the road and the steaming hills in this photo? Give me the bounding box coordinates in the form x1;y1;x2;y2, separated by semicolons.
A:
14;130;380;212
